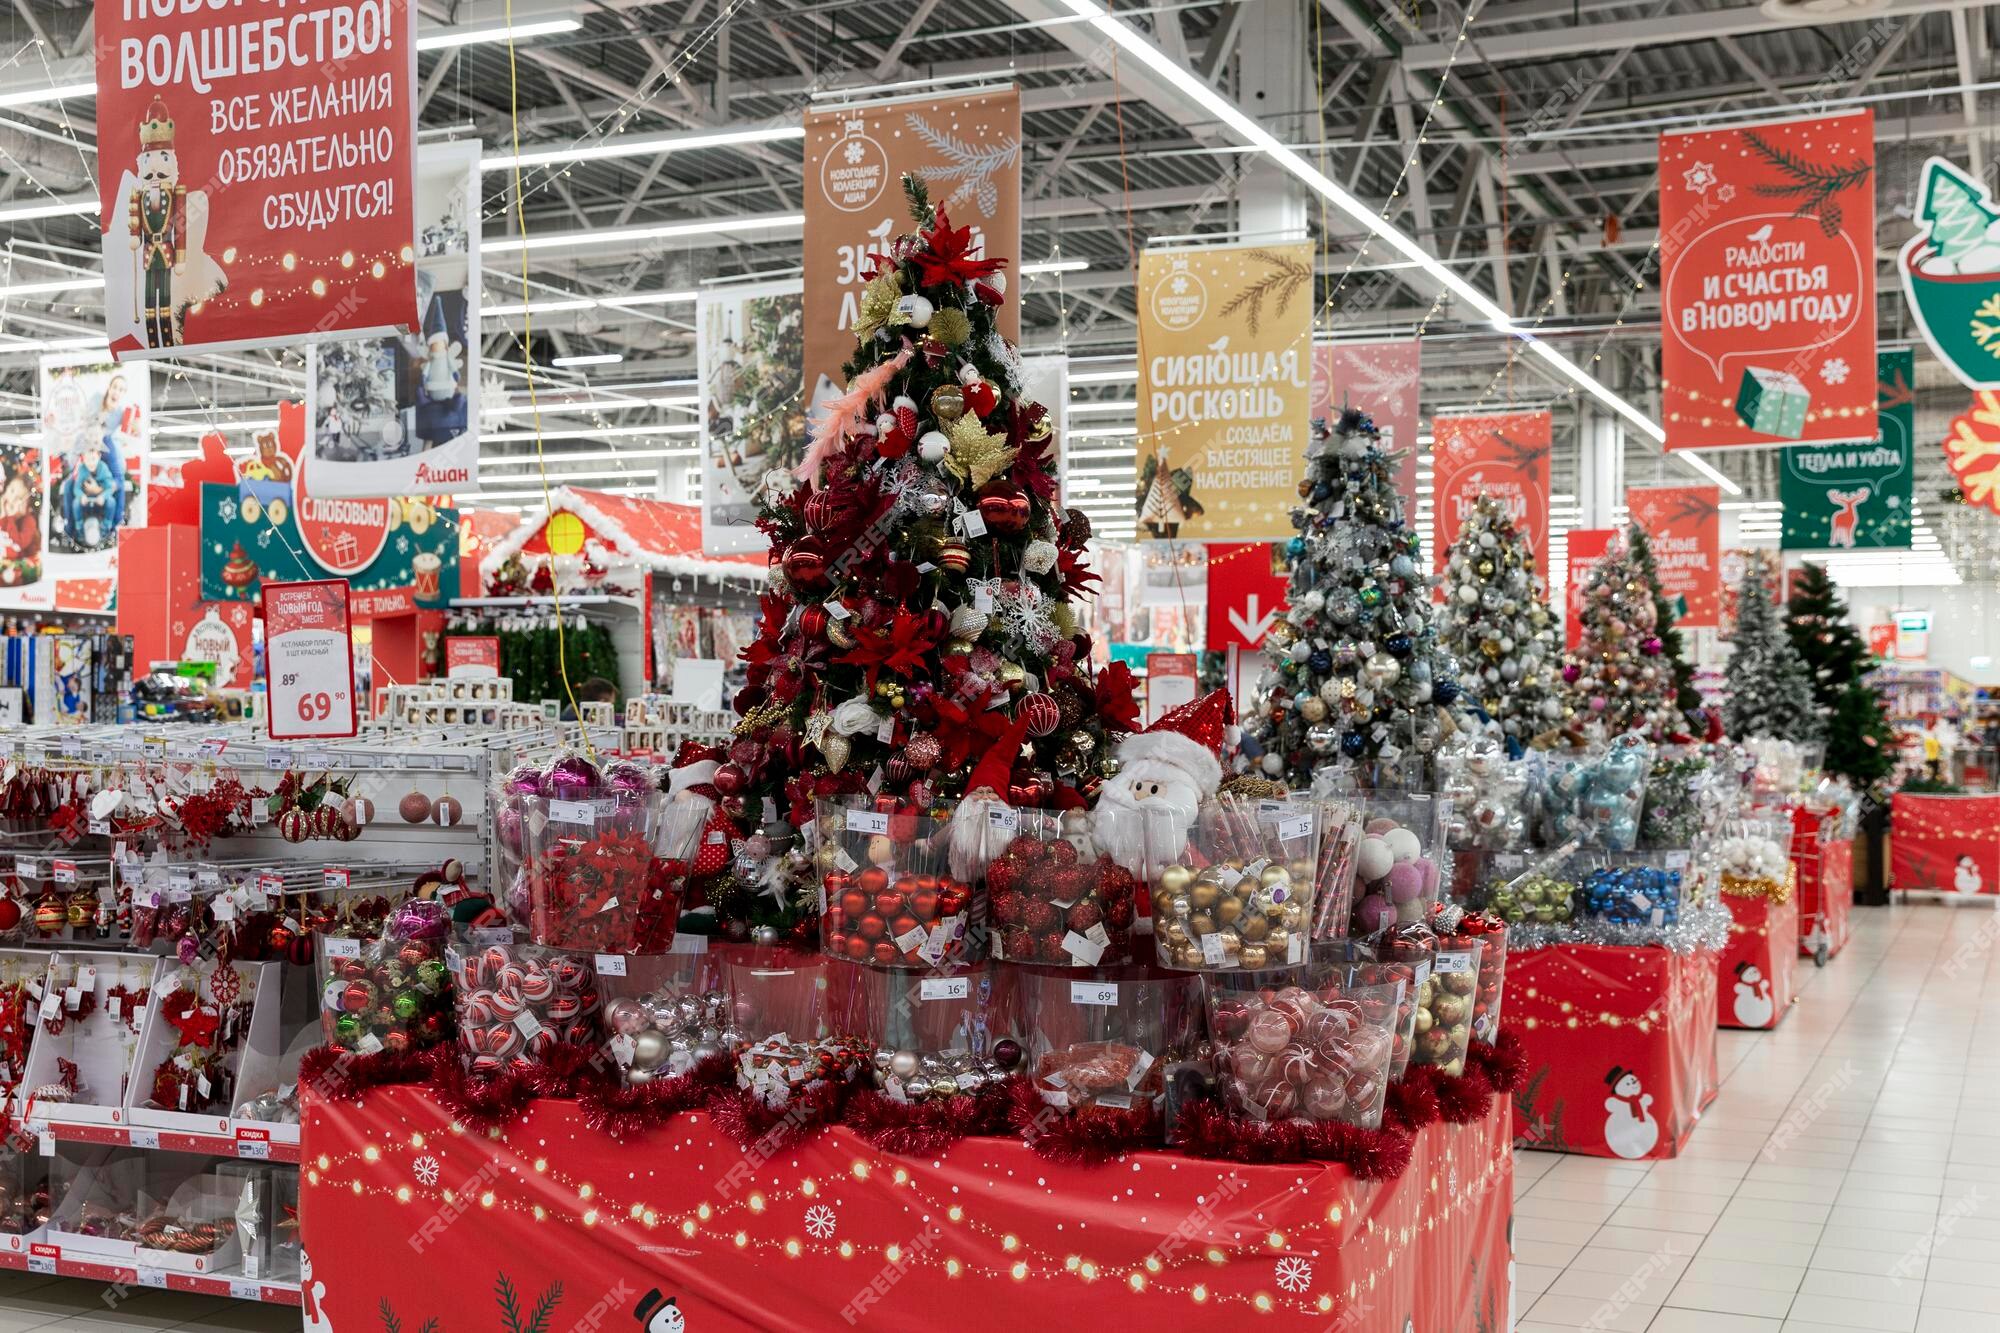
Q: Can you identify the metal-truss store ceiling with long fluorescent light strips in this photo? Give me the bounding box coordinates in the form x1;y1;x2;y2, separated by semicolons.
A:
0;0;2000;578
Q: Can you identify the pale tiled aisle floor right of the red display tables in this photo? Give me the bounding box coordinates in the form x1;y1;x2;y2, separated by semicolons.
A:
1514;901;2000;1333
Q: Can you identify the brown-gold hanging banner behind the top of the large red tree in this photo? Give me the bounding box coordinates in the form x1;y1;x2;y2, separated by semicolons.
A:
796;86;1020;418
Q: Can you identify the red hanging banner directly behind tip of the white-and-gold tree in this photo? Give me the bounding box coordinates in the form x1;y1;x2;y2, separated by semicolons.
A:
1430;408;1556;570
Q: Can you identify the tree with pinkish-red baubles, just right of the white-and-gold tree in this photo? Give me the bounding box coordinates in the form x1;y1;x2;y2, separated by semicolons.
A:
1562;528;1680;737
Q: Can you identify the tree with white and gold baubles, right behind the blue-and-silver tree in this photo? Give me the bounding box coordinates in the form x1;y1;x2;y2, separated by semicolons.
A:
1438;496;1562;745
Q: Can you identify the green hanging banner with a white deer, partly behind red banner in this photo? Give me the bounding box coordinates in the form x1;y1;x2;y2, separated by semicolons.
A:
1778;348;1916;550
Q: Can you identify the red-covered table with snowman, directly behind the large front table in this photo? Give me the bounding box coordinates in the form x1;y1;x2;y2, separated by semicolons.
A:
1506;945;1720;1159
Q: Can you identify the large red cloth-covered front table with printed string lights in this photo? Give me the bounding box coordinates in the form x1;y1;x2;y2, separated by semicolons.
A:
300;1087;1514;1333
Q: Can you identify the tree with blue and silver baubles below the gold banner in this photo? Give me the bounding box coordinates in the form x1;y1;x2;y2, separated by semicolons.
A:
1252;412;1458;785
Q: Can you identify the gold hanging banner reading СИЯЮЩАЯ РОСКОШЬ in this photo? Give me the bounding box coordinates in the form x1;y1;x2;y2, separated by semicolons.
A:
1134;242;1312;542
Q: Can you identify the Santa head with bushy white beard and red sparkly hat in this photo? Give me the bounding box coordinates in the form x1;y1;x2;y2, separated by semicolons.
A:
1090;691;1232;877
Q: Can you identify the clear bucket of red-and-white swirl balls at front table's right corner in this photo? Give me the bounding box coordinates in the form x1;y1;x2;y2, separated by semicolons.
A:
1206;965;1404;1129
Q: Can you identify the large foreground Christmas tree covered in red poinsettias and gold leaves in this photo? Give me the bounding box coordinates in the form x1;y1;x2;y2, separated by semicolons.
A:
712;180;1138;927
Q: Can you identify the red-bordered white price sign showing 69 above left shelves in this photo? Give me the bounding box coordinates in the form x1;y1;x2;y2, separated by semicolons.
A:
264;578;360;740
